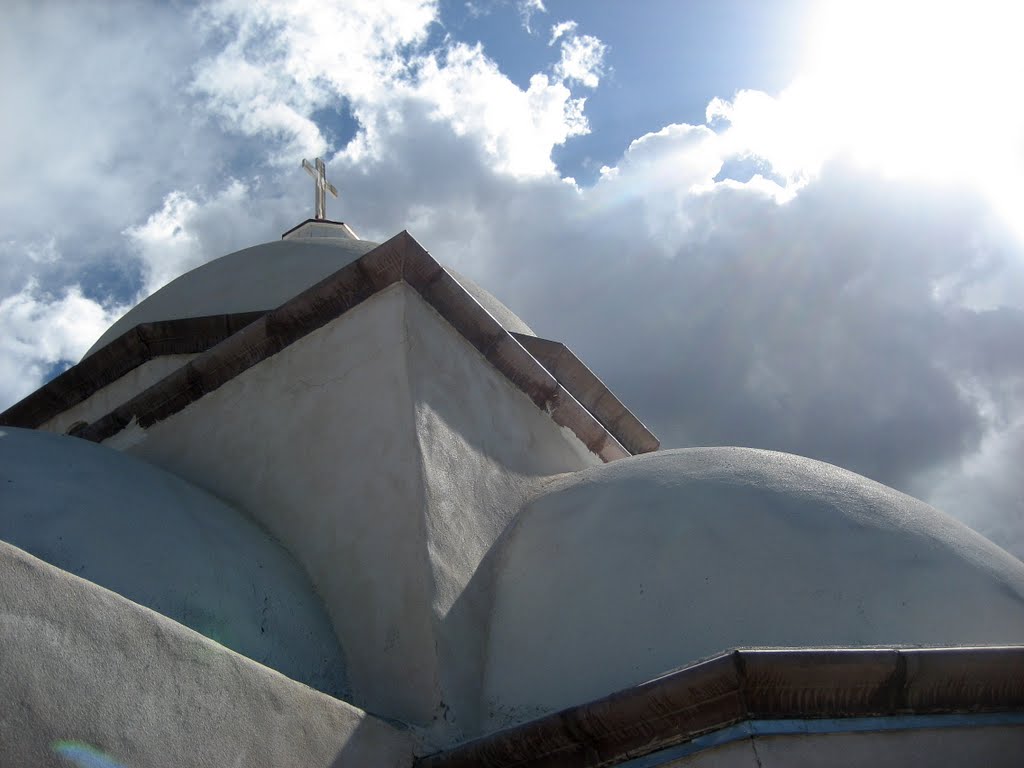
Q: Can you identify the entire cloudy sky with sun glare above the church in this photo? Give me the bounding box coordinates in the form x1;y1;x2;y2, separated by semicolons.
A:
0;0;1024;555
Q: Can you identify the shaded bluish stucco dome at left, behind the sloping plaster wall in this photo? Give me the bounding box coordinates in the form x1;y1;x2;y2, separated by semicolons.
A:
0;428;347;696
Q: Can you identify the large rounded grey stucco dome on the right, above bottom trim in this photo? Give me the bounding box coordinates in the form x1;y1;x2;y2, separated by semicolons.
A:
484;449;1024;727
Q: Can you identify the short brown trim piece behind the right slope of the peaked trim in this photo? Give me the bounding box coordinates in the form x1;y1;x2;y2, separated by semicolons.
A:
512;333;660;455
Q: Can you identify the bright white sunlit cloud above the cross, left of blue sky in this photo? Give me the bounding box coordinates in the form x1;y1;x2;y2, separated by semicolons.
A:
193;0;604;176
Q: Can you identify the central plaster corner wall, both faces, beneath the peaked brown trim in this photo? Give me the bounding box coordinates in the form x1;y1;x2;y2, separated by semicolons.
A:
110;284;599;724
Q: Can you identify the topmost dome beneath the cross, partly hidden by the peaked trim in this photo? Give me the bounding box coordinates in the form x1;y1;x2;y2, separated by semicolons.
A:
83;237;535;357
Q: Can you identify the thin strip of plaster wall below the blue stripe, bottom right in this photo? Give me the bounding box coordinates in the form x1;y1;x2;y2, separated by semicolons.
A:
659;725;1024;768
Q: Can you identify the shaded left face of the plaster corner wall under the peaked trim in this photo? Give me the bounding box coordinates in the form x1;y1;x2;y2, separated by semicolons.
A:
119;286;439;722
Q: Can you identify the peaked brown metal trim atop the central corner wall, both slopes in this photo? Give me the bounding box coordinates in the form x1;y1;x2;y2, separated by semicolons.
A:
56;231;630;462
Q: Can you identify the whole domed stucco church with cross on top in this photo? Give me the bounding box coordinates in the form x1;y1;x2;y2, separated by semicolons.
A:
0;161;1024;768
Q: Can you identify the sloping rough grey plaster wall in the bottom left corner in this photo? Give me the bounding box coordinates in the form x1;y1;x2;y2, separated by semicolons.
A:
0;543;413;768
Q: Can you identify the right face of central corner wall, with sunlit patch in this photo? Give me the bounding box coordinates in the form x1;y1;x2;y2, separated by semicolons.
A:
406;291;601;738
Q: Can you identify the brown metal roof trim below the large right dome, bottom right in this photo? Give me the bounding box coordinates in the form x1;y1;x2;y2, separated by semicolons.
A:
415;646;1024;768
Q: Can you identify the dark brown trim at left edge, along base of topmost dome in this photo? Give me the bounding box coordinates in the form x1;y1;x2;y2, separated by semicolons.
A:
0;311;264;429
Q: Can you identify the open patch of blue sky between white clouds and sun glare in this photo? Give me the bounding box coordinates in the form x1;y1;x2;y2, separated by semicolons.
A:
437;0;811;183
